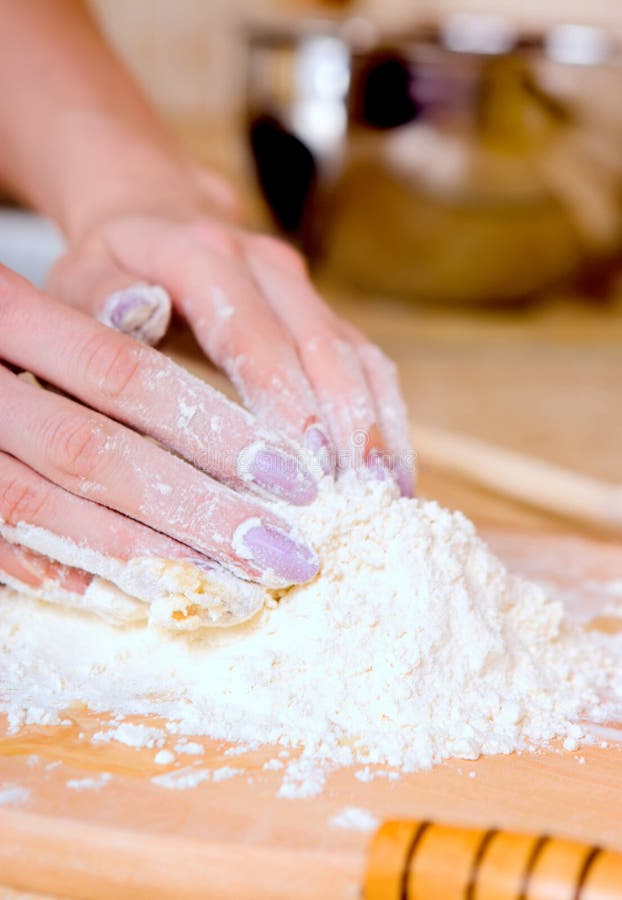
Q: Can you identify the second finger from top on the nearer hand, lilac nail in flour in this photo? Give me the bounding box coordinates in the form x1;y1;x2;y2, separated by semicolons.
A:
0;369;319;588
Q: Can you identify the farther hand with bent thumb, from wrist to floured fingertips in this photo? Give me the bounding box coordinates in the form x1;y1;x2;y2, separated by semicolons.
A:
49;196;413;496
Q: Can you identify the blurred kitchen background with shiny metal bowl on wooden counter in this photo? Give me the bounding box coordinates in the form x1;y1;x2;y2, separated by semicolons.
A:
0;0;622;527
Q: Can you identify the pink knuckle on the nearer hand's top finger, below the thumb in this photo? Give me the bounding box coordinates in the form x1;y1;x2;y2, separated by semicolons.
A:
81;329;142;400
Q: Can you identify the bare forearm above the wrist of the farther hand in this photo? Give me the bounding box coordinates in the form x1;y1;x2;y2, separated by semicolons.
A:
0;0;195;236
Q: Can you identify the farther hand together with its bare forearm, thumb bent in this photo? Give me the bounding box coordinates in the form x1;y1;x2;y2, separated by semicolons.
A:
0;0;412;494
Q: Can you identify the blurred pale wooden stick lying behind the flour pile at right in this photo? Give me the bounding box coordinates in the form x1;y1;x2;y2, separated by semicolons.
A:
413;425;622;534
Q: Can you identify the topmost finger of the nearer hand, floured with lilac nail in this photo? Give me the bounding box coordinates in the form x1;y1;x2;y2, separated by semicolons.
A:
0;270;317;505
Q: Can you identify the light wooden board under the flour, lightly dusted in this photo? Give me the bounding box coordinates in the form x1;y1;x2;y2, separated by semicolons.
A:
0;529;622;900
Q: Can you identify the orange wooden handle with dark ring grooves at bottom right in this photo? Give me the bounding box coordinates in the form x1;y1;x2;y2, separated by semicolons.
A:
364;822;622;900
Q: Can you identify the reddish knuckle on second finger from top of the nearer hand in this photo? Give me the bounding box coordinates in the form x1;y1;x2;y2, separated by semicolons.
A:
43;413;106;480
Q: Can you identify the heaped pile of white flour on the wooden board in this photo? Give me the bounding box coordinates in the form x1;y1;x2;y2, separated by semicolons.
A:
0;476;620;795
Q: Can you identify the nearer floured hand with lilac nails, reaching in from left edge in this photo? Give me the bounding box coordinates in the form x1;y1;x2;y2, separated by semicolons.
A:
0;267;319;587
